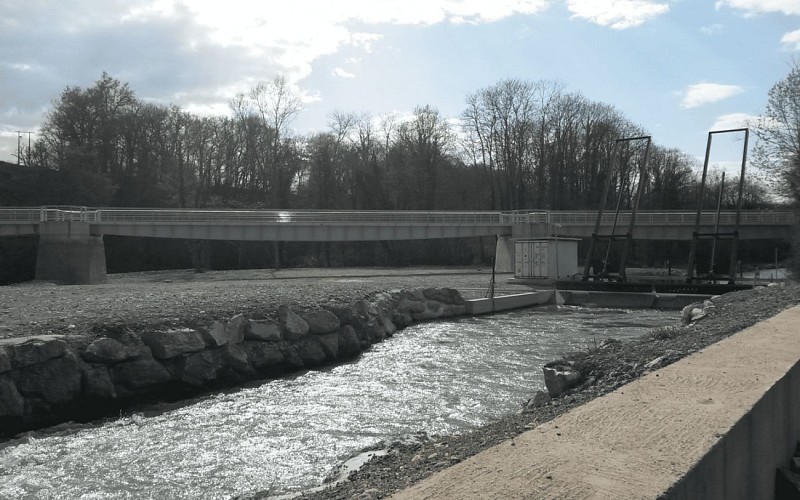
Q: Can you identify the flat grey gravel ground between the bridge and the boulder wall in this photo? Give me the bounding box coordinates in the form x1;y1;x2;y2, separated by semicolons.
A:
0;268;528;339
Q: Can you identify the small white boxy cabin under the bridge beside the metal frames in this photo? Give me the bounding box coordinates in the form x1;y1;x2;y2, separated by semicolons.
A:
514;238;580;279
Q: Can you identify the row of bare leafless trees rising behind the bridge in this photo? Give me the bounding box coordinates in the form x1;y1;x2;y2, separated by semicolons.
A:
28;73;776;210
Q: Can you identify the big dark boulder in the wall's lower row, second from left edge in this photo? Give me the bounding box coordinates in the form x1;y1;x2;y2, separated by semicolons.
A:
12;352;81;405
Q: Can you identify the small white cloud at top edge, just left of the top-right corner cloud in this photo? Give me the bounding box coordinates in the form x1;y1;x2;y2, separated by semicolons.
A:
567;0;669;29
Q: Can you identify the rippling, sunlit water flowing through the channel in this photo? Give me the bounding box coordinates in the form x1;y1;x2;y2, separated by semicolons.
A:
0;307;679;499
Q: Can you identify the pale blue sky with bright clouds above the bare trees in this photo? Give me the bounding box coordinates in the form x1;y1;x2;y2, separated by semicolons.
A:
0;0;800;177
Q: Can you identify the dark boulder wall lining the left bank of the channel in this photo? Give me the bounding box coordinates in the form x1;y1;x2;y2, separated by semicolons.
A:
0;288;466;436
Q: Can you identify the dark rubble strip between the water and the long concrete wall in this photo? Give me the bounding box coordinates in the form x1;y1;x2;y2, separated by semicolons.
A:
270;284;800;500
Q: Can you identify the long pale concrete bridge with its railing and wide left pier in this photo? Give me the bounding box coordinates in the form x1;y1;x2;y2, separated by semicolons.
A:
0;207;800;283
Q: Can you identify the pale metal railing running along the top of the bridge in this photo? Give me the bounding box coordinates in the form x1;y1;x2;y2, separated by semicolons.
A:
0;206;800;226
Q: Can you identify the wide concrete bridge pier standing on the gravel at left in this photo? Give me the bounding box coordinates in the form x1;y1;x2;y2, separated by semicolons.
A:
36;221;106;285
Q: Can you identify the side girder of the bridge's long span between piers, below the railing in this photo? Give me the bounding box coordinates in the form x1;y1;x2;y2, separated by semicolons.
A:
92;223;511;241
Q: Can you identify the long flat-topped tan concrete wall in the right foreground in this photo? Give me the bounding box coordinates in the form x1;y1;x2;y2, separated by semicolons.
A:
392;306;800;500
